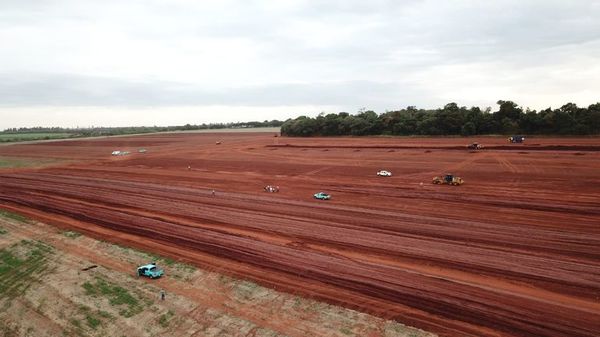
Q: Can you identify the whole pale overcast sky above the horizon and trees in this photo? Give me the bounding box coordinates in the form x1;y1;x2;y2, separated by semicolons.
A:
0;0;600;129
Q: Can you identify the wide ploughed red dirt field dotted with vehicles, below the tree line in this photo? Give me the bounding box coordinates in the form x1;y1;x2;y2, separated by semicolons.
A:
0;133;600;336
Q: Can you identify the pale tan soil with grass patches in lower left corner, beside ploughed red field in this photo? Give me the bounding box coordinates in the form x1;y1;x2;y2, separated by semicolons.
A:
0;213;434;337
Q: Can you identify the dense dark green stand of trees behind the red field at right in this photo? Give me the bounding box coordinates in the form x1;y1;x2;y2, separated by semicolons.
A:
281;101;600;136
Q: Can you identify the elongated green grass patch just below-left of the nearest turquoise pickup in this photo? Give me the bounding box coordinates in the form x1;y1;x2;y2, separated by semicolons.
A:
82;277;144;317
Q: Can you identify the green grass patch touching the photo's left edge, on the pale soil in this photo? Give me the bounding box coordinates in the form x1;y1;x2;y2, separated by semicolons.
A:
0;240;52;299
